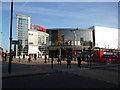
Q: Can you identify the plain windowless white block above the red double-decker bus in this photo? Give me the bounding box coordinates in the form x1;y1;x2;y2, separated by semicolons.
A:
90;26;119;49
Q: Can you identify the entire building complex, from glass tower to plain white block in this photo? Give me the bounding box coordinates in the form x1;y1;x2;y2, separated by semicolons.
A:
16;14;120;57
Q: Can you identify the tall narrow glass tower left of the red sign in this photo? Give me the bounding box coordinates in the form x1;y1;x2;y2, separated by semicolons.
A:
16;14;30;55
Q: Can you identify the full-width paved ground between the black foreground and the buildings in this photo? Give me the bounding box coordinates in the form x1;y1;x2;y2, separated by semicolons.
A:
2;58;119;85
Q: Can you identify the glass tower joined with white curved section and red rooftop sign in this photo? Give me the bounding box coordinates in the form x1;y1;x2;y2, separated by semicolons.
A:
14;14;49;56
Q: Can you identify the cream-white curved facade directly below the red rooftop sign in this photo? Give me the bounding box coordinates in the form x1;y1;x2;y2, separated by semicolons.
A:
28;30;49;57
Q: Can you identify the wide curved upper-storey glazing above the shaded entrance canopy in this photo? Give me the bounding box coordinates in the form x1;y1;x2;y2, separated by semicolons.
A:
48;29;93;46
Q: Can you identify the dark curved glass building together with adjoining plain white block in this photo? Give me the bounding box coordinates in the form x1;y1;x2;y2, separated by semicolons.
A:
47;26;120;57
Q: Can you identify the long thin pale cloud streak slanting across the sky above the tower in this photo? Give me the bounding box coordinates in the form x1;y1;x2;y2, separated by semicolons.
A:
8;5;85;18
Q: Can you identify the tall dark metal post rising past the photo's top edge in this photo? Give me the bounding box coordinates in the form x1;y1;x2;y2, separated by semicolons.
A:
8;0;13;74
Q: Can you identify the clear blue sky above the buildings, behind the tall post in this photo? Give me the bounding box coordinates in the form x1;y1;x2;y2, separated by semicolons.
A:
2;1;118;50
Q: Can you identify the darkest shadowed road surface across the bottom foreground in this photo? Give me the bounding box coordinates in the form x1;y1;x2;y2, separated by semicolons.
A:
2;72;117;89
